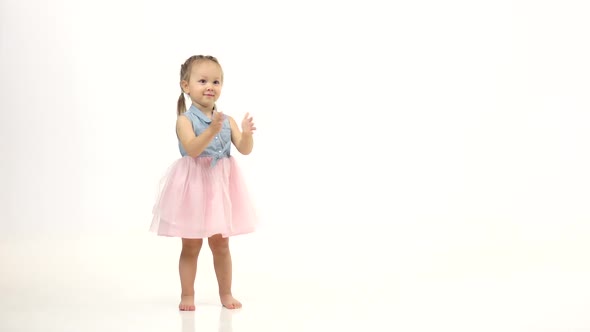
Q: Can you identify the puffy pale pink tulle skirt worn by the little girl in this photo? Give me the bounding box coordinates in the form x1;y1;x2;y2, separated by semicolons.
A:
150;156;257;239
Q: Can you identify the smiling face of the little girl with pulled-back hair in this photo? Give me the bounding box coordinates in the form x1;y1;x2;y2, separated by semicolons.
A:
182;61;223;111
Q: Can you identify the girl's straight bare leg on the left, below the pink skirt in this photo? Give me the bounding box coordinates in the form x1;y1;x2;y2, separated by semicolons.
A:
178;239;203;311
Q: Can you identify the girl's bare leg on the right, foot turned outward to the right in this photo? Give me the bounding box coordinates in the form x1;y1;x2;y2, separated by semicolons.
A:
208;234;242;309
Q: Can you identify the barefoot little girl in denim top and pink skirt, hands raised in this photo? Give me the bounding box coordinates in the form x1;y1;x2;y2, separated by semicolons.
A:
151;55;256;311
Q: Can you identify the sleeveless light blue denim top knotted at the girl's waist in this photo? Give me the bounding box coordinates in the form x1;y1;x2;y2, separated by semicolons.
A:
178;105;231;167
